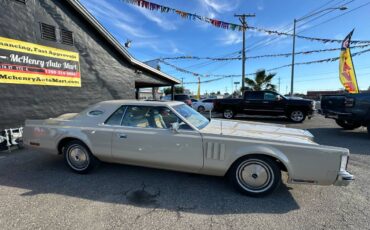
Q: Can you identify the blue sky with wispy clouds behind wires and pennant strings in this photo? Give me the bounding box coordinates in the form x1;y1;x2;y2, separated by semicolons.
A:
80;0;370;94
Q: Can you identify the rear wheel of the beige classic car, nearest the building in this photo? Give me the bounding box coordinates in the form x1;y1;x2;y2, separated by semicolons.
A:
63;140;99;174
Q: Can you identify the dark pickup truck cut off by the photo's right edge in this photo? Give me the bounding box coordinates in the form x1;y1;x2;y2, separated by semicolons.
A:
319;93;370;134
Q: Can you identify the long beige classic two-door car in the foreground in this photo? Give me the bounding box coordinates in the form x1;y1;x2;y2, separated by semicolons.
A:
23;100;353;196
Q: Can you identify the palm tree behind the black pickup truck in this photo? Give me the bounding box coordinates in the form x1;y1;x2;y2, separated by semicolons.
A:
245;69;276;91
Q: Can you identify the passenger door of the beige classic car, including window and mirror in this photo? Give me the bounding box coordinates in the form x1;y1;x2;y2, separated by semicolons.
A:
112;105;203;172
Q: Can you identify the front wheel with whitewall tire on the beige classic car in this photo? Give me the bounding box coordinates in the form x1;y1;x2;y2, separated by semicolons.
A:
229;156;281;197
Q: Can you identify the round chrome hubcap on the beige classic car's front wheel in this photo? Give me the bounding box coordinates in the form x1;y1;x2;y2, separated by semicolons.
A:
237;160;273;192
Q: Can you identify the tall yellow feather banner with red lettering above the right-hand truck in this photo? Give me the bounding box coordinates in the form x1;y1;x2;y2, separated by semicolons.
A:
339;31;359;93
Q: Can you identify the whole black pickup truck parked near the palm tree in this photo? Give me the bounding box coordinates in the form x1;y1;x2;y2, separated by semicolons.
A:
213;91;315;122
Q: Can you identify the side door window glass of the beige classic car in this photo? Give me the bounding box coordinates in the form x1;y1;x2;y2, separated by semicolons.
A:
122;106;190;129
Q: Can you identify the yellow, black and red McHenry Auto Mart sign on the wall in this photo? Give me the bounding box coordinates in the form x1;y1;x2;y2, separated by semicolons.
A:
0;37;81;87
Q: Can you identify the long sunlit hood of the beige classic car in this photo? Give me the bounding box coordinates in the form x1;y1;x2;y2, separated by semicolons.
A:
201;119;316;144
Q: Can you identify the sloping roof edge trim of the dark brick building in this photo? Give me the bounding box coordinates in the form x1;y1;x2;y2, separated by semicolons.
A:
67;0;181;84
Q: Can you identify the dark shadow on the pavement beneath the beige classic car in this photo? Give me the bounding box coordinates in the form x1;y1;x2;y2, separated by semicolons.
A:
0;150;299;215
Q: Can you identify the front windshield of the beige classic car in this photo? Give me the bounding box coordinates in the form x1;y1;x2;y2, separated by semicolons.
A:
173;104;209;129
